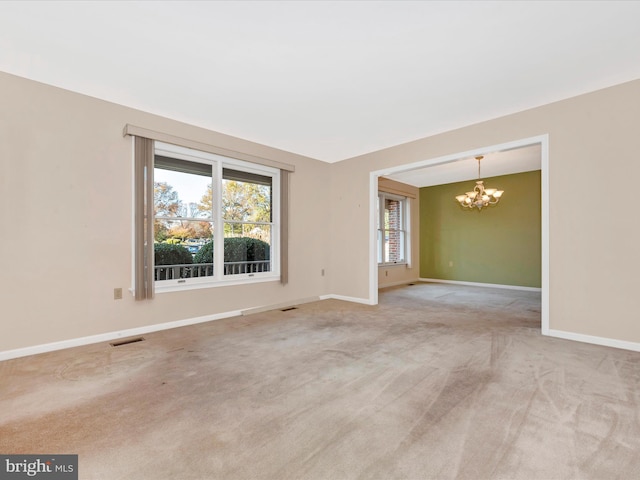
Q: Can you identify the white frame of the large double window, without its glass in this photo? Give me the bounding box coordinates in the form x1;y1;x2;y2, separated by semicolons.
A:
154;141;280;293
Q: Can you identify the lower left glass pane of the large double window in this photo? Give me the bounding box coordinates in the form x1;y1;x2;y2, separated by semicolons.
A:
154;219;213;280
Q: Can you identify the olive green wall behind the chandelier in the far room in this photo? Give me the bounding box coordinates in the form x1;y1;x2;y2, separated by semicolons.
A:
420;171;542;288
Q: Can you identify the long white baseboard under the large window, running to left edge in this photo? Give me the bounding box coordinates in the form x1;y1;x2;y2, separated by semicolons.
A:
0;310;242;362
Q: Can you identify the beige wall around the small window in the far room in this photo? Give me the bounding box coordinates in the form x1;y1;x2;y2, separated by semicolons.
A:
378;177;420;288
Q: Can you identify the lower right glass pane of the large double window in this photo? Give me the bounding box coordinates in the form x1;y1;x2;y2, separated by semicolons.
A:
224;222;271;275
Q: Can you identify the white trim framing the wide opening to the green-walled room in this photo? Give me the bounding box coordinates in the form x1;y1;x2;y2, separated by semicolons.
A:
369;134;550;335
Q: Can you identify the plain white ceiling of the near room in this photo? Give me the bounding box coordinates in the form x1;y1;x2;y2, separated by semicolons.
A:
0;1;640;165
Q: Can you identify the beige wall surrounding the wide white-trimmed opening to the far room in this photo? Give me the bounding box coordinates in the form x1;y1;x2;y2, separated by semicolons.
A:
330;80;640;342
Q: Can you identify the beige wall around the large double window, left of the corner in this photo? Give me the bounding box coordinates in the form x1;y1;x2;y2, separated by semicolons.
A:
0;74;330;352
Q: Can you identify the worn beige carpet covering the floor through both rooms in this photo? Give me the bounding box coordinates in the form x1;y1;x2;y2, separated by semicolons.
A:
0;284;640;480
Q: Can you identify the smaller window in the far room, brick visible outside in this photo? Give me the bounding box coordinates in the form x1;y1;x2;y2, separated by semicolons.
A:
377;192;409;265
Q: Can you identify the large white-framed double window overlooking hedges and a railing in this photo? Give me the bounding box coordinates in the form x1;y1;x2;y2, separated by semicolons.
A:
153;142;280;290
